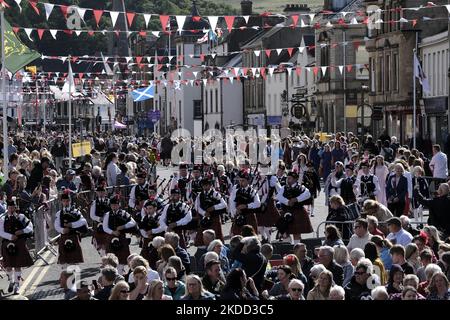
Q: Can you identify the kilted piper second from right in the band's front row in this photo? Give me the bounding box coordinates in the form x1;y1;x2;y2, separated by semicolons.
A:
229;171;261;235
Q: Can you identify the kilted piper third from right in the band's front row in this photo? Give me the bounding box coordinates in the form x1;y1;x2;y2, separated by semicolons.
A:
194;177;227;247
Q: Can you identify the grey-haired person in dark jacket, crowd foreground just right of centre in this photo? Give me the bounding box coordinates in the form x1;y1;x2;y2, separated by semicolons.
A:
231;237;267;291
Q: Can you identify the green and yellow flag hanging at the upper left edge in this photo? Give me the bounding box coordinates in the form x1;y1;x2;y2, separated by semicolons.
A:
5;19;41;74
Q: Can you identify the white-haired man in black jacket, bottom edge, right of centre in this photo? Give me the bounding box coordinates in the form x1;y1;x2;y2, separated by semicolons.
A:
344;259;373;300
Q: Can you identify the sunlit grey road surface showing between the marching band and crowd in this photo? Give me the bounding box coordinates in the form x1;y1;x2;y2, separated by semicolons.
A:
0;167;328;300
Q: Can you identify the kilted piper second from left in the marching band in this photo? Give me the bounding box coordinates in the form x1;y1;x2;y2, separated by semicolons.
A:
55;190;87;268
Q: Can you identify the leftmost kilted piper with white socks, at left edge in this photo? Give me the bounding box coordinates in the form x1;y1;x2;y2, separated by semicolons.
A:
0;199;33;293
